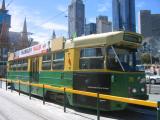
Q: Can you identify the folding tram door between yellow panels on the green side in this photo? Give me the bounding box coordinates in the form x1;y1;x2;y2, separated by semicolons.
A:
31;57;39;83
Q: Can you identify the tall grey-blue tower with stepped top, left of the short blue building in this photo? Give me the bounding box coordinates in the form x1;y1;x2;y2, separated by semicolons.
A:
68;0;85;38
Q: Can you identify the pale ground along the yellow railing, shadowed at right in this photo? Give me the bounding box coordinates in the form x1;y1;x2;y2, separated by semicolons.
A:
0;81;160;120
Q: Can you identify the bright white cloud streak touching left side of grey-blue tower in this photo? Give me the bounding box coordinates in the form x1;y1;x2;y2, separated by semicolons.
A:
41;22;67;32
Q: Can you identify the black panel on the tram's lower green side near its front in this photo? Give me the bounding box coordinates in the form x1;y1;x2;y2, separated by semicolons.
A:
73;72;111;110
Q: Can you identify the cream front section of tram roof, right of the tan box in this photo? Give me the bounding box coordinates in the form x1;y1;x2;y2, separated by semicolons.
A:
65;31;142;49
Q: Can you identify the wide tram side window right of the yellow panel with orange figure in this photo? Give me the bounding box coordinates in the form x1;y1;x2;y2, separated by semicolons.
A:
80;48;104;69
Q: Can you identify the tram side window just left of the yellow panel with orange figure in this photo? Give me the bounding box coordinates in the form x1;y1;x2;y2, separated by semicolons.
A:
52;51;64;70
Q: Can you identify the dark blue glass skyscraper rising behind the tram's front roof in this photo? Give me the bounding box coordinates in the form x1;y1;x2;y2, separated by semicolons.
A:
112;0;136;32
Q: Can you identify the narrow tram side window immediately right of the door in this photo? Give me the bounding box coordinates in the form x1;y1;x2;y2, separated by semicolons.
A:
42;54;52;70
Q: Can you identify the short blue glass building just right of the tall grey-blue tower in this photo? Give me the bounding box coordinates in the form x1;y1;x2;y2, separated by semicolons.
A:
85;23;96;35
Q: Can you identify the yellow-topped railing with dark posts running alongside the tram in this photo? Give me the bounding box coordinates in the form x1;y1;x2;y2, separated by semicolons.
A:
0;79;160;120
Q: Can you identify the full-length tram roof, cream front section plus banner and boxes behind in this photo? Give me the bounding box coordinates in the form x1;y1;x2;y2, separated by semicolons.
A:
8;31;142;60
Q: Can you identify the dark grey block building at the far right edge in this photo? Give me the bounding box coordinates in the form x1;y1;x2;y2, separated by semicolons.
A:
138;10;160;37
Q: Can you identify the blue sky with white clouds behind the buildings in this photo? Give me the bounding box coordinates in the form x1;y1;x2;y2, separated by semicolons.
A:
1;0;160;42
